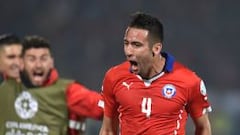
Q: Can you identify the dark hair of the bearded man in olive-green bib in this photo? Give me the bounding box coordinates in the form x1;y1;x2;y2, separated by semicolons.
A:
22;35;51;56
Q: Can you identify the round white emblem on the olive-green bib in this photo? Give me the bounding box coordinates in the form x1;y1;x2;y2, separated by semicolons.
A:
15;91;38;119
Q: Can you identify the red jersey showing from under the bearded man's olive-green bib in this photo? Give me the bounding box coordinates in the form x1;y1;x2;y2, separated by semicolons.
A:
44;69;104;135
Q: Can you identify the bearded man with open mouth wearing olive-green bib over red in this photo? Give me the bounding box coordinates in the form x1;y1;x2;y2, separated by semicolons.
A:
0;36;103;135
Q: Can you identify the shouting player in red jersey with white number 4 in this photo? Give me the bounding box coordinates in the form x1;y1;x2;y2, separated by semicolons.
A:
100;13;211;135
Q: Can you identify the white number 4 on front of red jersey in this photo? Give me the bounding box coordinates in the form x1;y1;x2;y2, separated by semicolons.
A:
142;98;152;117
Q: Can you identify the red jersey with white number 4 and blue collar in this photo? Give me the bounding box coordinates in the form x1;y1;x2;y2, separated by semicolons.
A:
103;54;211;135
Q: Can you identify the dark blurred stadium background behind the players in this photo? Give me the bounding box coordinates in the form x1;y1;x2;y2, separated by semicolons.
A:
0;0;240;135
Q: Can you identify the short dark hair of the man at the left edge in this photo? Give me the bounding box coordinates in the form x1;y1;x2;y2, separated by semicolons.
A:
0;34;21;47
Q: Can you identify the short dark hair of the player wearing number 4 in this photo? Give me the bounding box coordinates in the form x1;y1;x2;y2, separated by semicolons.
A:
128;12;163;43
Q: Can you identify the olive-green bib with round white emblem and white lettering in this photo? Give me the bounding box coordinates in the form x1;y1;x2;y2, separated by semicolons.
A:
0;79;72;135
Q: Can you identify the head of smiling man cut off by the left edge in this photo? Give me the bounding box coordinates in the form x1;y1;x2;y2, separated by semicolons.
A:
0;34;22;82
